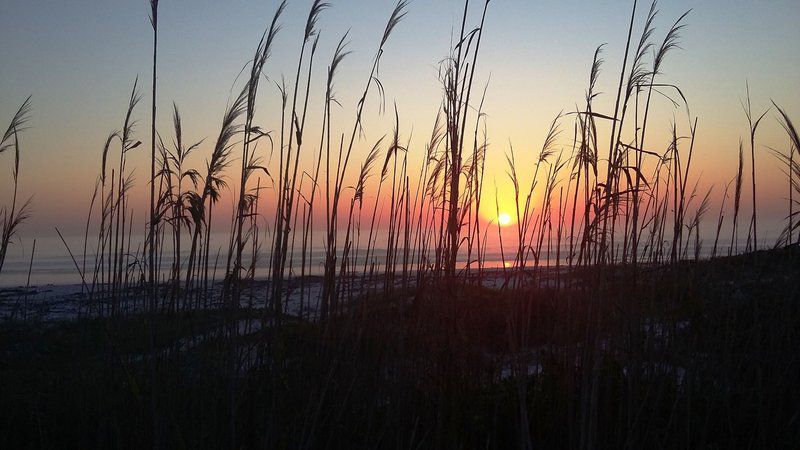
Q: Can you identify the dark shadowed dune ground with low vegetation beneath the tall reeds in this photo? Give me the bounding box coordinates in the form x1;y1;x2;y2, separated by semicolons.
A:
0;247;800;449
